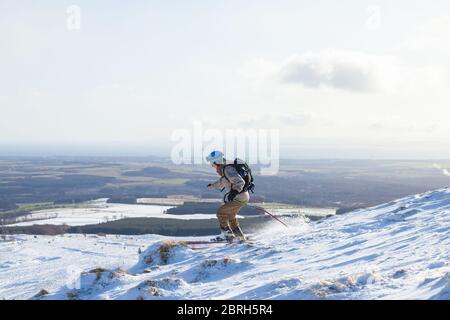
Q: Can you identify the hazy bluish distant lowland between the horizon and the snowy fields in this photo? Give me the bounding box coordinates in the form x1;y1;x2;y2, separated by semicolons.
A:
0;157;450;217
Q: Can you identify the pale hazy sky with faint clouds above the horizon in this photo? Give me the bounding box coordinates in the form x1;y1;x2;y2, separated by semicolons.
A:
0;0;450;159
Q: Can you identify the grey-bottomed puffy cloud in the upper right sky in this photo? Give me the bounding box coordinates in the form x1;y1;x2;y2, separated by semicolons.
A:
279;50;398;92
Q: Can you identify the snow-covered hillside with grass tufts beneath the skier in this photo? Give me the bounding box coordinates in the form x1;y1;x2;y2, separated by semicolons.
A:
0;189;450;299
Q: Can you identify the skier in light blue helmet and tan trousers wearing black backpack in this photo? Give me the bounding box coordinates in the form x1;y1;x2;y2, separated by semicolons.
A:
206;151;254;242
